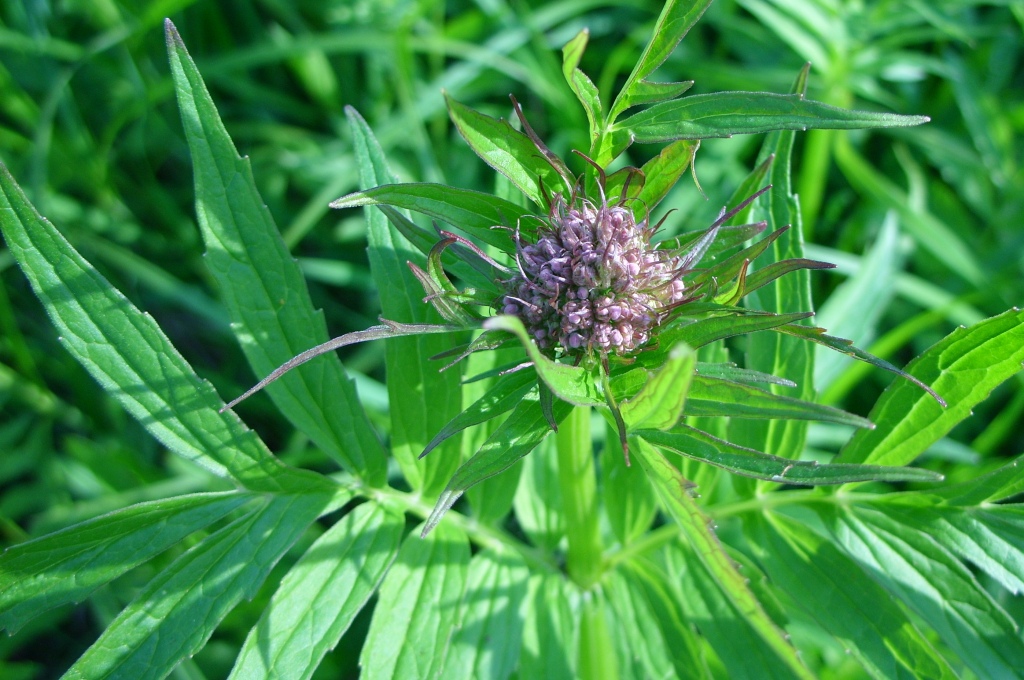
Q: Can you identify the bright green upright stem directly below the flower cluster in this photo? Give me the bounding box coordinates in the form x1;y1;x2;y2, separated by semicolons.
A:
555;407;603;588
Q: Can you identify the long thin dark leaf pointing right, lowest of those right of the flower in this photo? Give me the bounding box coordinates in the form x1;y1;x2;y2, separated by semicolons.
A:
633;425;943;485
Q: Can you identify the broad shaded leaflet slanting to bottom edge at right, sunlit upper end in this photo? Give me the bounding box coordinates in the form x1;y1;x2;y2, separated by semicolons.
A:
745;514;956;679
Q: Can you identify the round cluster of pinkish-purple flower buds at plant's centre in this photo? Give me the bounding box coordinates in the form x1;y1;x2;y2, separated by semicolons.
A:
502;195;685;354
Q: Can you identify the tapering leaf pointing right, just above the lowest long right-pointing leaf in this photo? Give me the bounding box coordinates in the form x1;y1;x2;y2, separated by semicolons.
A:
686;375;874;429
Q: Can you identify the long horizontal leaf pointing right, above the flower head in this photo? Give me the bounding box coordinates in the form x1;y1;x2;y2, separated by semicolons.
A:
612;92;929;143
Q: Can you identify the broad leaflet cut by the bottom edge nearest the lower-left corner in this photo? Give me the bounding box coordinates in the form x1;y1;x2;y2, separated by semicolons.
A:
65;494;332;680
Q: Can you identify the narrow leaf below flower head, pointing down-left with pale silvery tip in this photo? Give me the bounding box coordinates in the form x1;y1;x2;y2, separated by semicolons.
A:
423;394;572;536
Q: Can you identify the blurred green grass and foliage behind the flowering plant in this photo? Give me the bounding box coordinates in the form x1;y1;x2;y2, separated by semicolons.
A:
0;0;1024;677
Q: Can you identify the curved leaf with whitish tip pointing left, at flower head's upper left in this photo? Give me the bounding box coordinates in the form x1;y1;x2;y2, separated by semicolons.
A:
331;183;536;255
